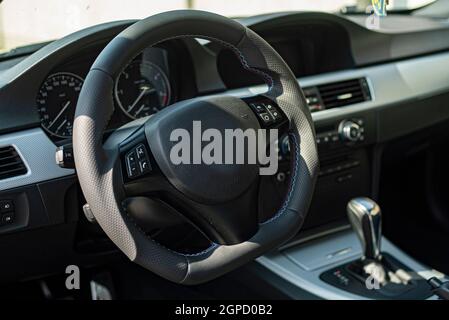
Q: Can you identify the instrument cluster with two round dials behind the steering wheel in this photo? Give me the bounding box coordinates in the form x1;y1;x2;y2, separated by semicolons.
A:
36;47;174;139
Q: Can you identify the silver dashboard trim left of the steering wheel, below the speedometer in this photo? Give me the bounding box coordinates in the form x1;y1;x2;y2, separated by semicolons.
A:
0;128;75;190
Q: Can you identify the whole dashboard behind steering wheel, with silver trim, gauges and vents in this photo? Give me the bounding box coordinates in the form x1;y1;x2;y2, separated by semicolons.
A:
0;12;449;280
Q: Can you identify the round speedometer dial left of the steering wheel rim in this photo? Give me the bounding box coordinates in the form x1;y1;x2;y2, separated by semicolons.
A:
36;72;83;138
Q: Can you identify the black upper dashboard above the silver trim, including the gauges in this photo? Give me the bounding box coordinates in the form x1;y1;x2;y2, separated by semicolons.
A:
0;13;449;141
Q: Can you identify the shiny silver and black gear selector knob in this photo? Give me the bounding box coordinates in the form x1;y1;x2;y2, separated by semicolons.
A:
346;198;382;260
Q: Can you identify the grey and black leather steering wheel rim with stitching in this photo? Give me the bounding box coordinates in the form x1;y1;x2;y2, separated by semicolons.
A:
73;10;318;284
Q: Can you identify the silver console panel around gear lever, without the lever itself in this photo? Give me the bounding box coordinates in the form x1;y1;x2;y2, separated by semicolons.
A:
257;230;444;300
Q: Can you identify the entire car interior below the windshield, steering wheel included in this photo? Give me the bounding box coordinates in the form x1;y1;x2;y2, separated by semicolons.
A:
0;0;449;300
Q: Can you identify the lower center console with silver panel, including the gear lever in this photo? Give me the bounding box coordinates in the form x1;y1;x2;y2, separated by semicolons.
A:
258;198;448;300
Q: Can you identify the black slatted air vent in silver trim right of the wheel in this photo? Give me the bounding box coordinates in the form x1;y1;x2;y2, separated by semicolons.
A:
317;78;371;109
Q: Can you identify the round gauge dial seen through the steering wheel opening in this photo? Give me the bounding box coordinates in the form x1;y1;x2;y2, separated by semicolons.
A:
115;60;170;119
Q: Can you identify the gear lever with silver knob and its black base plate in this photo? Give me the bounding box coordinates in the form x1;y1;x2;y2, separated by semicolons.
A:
322;198;426;299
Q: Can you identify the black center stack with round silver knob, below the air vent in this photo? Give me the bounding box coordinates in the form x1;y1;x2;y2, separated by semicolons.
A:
304;111;376;230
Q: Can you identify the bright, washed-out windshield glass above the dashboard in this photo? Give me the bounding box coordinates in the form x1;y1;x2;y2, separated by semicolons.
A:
0;0;432;52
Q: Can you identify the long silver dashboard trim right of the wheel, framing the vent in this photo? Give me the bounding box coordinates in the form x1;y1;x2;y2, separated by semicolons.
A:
226;52;449;121
